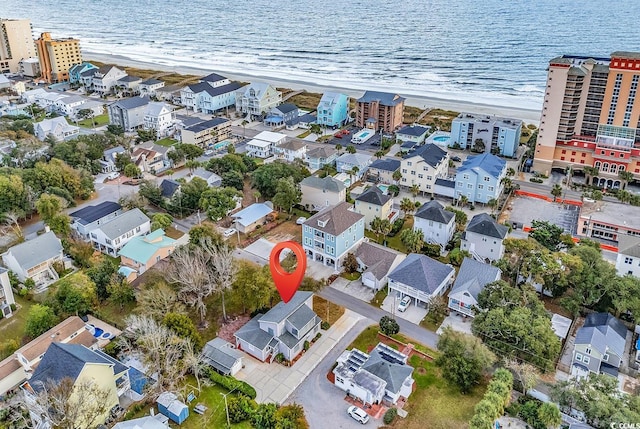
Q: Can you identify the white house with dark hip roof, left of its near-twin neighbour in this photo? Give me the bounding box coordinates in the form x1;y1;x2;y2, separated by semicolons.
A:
413;200;456;253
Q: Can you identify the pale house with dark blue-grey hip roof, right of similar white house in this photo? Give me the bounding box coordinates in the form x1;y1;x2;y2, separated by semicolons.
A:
460;213;509;261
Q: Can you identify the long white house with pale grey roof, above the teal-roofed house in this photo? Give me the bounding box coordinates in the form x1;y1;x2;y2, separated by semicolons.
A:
90;208;151;257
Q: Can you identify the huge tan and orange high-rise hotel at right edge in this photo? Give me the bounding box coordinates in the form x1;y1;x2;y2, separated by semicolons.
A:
533;52;640;188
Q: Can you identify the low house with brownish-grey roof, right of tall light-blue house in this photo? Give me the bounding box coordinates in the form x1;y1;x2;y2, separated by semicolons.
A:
355;242;407;291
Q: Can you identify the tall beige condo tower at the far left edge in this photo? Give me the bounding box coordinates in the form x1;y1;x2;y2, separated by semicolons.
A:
0;18;36;73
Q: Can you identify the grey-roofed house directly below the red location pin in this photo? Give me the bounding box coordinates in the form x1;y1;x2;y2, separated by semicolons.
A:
234;291;321;362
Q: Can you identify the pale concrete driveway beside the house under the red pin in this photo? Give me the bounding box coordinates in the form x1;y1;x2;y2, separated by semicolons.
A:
236;310;370;404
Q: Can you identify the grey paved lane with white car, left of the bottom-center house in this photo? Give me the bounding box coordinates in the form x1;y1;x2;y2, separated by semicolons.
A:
287;318;383;429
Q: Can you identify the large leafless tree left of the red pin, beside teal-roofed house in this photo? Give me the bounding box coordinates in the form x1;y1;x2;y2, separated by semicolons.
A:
166;242;216;324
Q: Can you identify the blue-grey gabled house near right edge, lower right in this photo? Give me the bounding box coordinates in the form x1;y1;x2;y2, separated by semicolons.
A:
575;313;627;357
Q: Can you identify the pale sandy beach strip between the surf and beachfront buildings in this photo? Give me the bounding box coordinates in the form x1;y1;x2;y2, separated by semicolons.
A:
83;52;540;126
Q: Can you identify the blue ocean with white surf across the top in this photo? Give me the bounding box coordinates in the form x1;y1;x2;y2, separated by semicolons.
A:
0;0;640;109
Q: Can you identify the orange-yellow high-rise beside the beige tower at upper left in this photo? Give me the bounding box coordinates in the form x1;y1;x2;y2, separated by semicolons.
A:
36;33;82;83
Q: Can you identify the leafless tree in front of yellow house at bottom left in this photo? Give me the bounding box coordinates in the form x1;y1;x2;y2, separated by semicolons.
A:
25;377;117;429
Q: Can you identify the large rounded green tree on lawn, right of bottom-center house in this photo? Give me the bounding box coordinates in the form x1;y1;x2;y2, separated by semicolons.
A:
436;327;496;393
